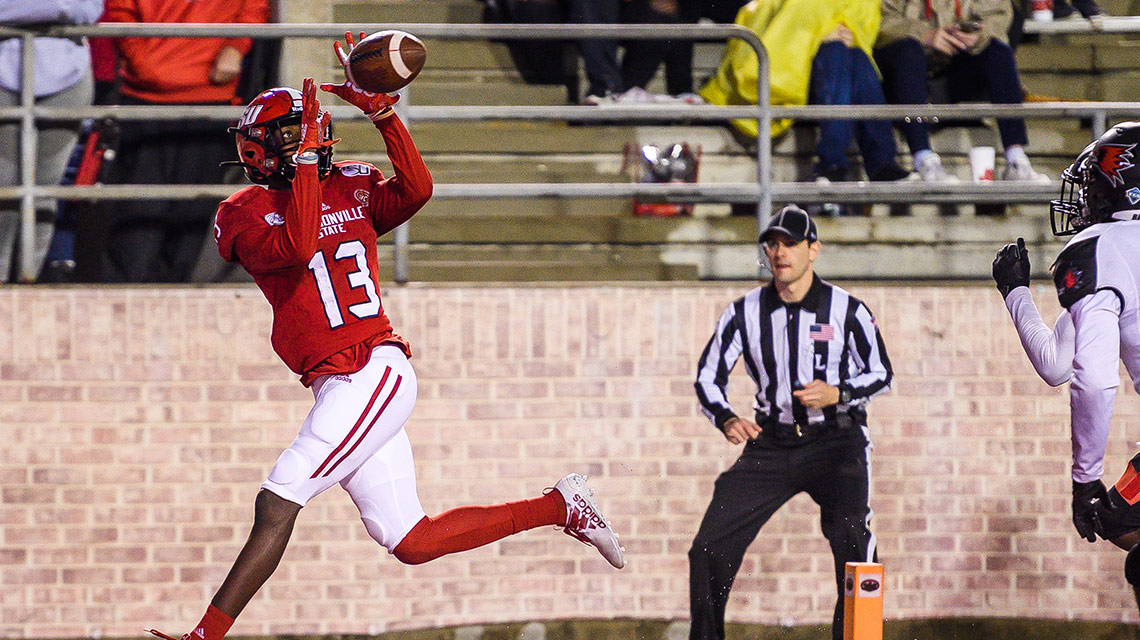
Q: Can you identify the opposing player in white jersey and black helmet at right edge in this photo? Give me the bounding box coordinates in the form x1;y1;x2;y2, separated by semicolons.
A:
994;122;1140;606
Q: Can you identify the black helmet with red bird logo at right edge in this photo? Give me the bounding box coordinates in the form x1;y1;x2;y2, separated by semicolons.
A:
1049;122;1140;235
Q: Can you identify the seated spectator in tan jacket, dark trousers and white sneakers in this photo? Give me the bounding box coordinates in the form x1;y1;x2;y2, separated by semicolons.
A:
874;0;1049;183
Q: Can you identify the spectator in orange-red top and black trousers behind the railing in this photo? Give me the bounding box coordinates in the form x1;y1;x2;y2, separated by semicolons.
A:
97;0;269;282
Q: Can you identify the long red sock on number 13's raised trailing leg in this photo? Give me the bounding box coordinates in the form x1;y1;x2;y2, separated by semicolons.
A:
394;491;567;563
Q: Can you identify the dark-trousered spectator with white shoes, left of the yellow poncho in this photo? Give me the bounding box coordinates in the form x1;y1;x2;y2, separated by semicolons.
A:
568;0;702;104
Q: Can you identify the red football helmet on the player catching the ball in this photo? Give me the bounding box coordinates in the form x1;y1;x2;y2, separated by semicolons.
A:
229;87;333;188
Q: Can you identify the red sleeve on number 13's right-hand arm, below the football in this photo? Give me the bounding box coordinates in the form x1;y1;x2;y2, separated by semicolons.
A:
368;114;433;235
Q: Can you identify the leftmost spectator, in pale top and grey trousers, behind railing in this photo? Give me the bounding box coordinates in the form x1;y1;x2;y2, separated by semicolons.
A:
0;0;103;282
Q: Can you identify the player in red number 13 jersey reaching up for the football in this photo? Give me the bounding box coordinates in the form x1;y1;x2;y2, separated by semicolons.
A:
152;34;625;640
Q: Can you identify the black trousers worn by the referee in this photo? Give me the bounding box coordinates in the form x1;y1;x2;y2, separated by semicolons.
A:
689;426;877;640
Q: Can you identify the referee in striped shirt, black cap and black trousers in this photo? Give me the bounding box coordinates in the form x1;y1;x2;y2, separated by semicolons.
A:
689;205;891;640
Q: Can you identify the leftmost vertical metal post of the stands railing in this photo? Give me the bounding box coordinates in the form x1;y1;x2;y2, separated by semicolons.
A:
14;33;36;282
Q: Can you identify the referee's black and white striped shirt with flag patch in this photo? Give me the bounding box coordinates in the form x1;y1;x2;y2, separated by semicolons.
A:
695;274;893;430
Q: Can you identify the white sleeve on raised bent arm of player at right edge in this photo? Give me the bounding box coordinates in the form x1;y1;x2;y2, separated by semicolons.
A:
1005;286;1075;387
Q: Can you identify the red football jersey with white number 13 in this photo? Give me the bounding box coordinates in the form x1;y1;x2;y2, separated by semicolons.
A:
214;118;432;386
